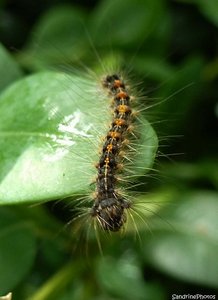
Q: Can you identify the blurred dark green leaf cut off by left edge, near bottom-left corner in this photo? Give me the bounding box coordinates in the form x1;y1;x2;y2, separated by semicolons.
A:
0;221;36;293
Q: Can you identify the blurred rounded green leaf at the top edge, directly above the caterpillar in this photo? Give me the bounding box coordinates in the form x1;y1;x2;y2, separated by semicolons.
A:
90;0;164;49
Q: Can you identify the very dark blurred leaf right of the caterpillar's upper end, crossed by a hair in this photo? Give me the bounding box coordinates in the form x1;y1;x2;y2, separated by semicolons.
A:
154;56;204;134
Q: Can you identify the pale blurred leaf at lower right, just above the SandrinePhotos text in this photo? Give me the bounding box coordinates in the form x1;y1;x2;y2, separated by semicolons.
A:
144;191;218;287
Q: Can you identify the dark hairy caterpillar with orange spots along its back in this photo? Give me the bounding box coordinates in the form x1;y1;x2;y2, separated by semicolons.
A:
92;74;136;231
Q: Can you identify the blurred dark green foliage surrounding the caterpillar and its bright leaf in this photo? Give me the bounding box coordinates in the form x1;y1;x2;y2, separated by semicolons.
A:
0;0;218;300
